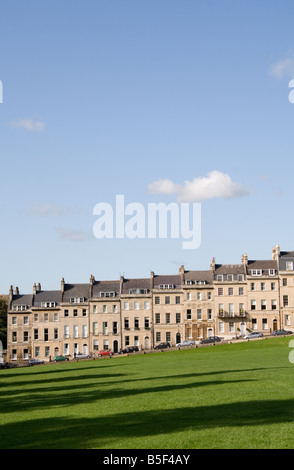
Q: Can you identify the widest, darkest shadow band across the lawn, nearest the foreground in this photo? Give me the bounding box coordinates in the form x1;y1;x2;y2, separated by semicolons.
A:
0;400;294;449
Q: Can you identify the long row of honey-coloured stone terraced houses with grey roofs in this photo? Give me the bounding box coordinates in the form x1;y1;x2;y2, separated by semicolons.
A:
7;245;294;361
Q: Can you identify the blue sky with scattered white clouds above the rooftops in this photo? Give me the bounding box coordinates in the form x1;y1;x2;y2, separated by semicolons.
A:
0;0;294;293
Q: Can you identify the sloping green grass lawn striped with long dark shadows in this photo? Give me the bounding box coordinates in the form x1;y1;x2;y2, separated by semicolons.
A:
0;337;294;449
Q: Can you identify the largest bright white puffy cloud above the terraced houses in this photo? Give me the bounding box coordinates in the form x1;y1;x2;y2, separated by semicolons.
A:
148;170;249;202
